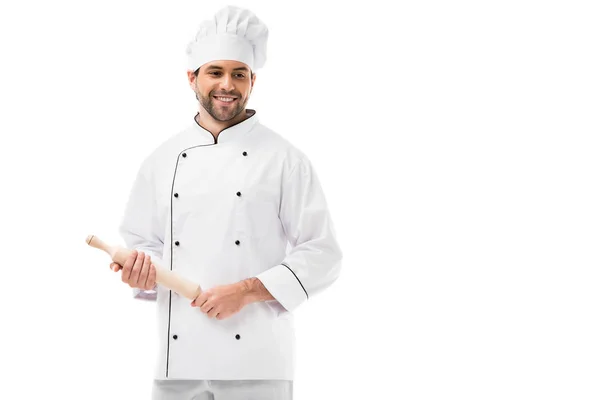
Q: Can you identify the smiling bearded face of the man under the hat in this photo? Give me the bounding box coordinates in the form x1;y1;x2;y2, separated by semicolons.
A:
188;61;256;121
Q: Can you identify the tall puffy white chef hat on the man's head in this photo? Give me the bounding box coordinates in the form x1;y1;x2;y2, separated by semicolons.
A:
186;6;269;71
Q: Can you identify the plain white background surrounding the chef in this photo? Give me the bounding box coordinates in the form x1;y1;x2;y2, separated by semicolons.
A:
0;0;600;400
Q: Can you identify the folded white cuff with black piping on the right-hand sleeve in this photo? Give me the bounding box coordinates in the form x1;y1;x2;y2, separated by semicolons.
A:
256;264;308;312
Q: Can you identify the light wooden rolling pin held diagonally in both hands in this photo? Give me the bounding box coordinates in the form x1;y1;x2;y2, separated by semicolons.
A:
85;235;202;300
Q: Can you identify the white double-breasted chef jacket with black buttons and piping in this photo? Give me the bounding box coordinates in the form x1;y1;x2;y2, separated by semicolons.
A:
119;110;342;380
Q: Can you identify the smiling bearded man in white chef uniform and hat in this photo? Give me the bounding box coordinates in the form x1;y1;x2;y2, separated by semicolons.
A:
111;3;342;400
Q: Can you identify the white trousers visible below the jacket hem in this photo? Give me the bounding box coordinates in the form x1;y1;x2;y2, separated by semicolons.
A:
152;379;294;400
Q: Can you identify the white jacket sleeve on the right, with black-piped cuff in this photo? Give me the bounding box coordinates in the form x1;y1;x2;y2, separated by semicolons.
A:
256;157;342;311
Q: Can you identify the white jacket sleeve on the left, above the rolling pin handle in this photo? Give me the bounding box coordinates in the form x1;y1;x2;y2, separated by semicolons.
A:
119;162;164;300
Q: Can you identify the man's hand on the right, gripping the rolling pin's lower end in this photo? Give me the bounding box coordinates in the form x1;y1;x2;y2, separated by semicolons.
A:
191;281;248;320
